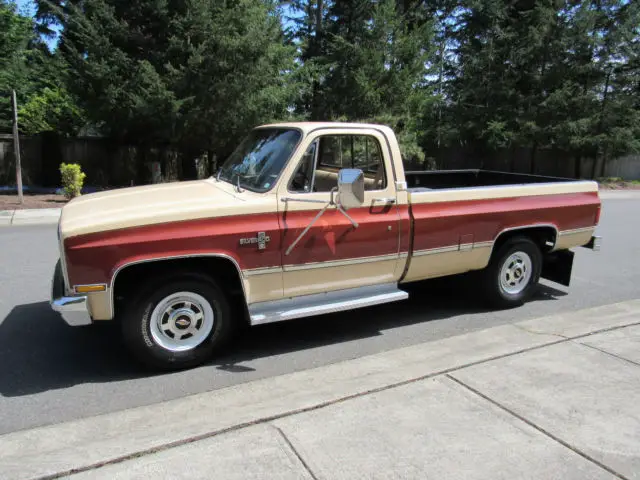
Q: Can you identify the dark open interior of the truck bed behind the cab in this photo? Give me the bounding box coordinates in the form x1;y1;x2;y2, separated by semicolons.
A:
405;170;579;192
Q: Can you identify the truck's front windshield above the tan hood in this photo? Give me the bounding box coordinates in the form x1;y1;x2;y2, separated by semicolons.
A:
218;128;300;192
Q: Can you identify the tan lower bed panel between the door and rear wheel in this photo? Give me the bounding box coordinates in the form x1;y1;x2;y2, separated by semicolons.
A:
402;246;491;283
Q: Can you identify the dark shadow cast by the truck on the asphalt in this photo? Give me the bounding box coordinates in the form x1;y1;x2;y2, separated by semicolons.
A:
0;281;565;397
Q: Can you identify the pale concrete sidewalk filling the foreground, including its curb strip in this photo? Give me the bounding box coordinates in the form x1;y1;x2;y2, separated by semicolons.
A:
0;300;640;480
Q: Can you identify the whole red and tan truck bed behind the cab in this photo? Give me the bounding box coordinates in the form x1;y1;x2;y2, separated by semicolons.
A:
403;170;600;282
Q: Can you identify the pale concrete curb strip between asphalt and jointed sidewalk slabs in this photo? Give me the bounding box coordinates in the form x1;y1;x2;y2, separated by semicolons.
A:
0;300;640;479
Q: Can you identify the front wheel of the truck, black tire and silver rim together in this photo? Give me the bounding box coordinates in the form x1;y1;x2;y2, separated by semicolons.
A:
122;277;232;370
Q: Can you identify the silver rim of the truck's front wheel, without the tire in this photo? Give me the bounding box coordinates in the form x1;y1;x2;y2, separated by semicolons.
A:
150;292;215;352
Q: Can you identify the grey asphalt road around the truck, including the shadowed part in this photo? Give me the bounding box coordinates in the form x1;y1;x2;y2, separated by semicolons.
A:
0;194;640;434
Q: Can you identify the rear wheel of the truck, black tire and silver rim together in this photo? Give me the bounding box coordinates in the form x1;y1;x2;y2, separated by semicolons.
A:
482;237;542;308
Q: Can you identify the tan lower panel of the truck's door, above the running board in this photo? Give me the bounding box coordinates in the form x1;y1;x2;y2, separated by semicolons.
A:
284;259;398;296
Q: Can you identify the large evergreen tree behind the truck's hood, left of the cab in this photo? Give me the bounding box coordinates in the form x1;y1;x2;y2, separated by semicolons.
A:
39;0;293;178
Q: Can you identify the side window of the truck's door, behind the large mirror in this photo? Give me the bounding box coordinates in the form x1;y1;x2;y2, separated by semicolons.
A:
289;135;387;193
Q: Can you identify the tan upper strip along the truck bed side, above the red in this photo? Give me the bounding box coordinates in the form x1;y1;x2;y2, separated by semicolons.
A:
409;181;598;204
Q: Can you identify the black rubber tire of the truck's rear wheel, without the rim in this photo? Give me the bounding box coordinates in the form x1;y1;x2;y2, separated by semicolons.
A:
481;236;542;308
